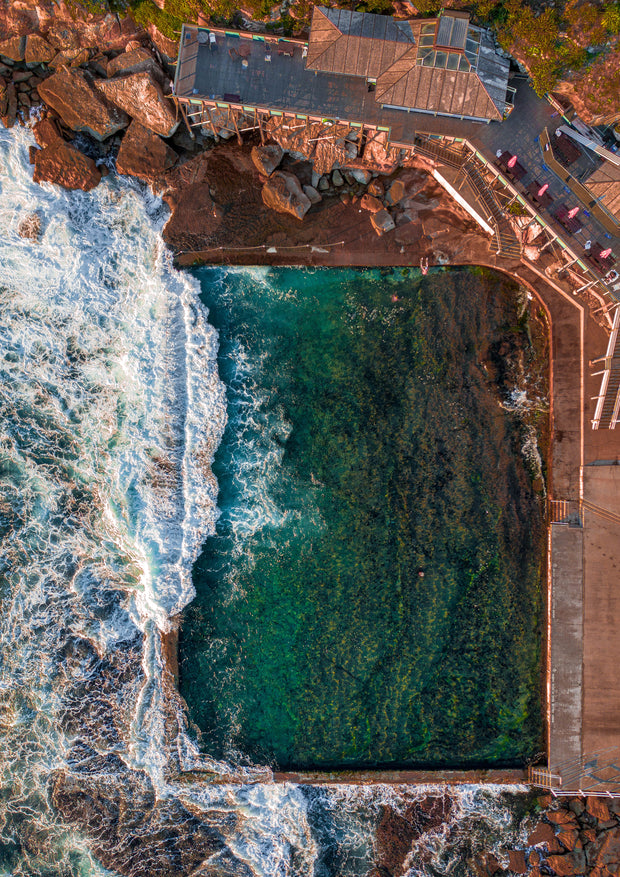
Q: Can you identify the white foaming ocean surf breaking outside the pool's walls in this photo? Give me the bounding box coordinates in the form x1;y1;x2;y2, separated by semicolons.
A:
0;128;544;877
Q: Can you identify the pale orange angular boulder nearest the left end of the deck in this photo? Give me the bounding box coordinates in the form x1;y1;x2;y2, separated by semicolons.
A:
95;73;179;137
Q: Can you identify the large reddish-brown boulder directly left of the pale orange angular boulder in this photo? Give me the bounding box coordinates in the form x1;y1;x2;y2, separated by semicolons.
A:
37;69;129;140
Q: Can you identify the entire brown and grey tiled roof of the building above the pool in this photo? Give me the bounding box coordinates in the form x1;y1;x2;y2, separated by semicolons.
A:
306;6;510;120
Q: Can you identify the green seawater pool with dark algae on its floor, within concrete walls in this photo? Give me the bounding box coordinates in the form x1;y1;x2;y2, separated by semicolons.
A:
180;268;546;768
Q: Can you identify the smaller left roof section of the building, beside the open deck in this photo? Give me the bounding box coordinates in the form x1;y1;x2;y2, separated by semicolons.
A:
306;6;414;79
